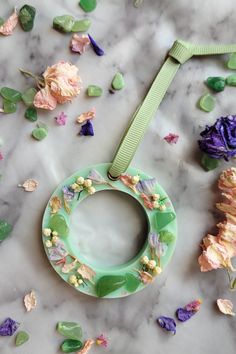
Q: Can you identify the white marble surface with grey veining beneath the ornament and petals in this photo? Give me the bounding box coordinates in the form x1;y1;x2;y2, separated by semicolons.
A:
0;0;236;354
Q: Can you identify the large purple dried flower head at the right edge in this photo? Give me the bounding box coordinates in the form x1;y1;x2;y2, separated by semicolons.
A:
198;115;236;161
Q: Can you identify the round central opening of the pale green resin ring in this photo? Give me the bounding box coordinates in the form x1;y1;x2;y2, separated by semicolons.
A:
70;190;149;268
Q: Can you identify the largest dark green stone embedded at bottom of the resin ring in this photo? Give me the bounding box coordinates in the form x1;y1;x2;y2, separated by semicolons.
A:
96;275;126;297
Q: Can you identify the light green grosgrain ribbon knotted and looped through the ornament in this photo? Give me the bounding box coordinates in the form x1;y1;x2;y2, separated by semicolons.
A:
108;40;236;180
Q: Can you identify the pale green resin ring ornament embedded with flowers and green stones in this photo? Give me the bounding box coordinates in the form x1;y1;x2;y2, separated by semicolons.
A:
42;163;177;298
